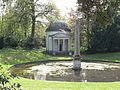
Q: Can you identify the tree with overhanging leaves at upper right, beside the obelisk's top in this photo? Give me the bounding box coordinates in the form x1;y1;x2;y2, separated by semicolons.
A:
78;0;120;48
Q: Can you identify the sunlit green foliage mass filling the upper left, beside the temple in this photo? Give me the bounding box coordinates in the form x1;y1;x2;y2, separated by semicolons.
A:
0;0;60;46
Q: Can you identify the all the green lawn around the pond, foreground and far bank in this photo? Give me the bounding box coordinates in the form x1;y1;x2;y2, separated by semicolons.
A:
0;49;120;90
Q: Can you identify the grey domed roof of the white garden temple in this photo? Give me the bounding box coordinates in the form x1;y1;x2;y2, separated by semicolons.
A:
46;21;70;31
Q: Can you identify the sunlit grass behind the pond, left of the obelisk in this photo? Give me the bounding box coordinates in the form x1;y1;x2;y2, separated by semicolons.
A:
0;49;71;65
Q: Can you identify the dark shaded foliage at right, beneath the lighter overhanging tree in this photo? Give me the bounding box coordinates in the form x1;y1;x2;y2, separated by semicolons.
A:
88;16;120;53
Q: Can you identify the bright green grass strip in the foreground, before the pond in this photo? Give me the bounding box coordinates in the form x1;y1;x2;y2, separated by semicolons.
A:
13;78;120;90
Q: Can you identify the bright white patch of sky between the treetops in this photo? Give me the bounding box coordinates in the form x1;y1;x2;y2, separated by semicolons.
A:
52;0;77;16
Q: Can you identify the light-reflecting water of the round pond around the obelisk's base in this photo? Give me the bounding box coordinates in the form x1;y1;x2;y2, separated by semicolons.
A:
10;61;120;82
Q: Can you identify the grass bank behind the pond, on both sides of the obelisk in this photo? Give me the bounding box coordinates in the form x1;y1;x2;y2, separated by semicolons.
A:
0;49;120;65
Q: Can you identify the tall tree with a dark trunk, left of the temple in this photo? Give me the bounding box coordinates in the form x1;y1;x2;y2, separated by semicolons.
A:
15;0;53;39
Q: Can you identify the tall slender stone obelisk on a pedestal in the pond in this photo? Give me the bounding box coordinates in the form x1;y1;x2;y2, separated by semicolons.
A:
73;19;81;70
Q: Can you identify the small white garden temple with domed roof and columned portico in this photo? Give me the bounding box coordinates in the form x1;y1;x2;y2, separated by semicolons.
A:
46;21;71;55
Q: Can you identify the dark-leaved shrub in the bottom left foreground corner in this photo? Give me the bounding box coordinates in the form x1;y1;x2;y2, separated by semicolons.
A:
0;65;21;90
